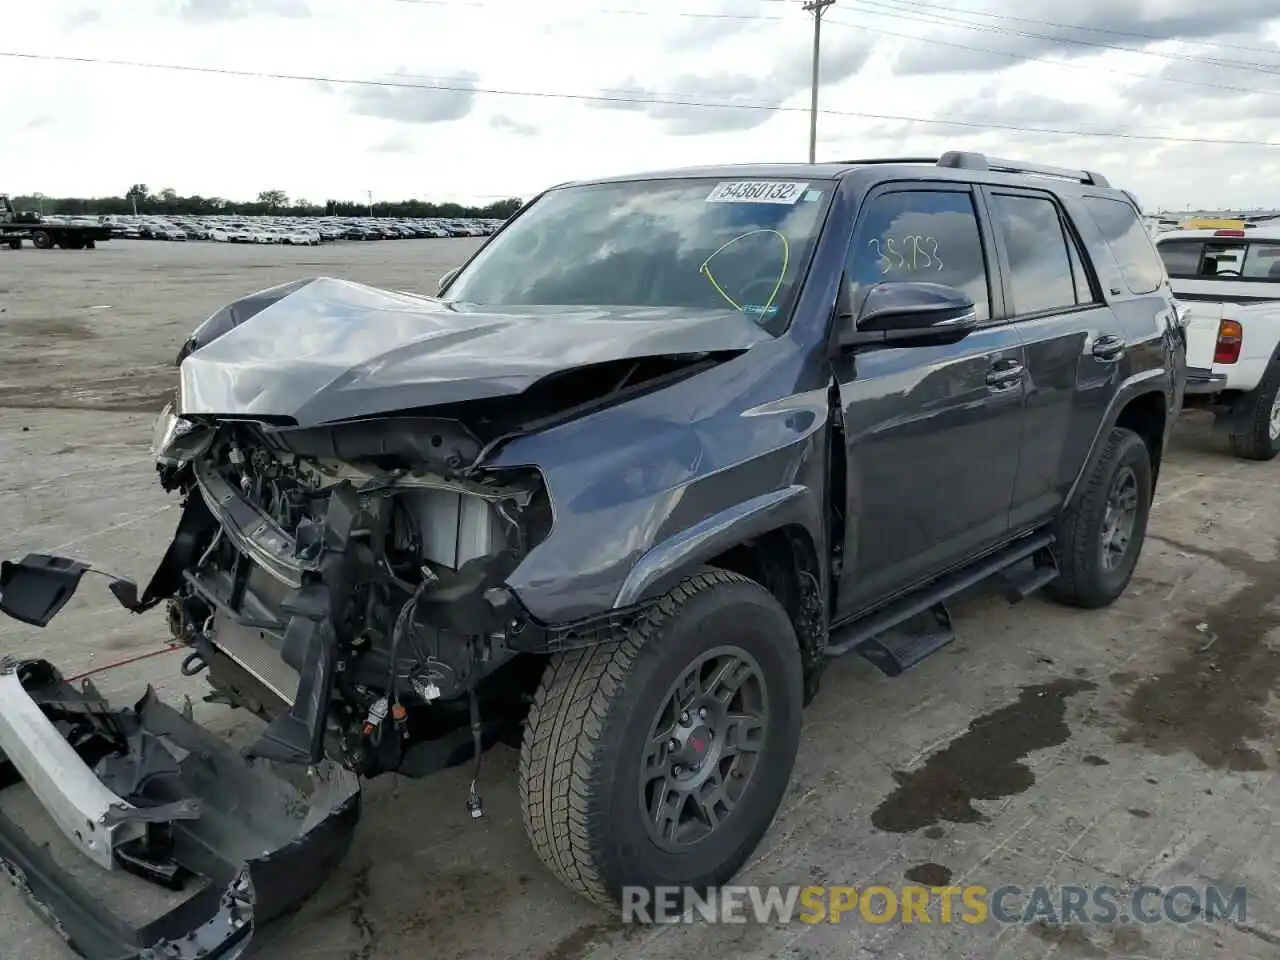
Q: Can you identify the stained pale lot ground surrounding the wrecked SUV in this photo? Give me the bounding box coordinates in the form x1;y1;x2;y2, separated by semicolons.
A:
0;241;1280;960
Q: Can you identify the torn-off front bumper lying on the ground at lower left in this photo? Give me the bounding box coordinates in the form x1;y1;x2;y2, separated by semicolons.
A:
0;660;360;960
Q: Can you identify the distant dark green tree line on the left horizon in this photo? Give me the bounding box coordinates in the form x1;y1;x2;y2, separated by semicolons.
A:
13;183;522;220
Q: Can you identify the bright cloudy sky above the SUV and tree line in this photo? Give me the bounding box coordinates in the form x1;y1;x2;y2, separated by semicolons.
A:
0;0;1280;209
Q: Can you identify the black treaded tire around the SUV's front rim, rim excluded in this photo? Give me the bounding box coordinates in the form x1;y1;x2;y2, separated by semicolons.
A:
520;568;804;905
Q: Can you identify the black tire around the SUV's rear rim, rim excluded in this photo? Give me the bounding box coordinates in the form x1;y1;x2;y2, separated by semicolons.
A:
1047;426;1152;609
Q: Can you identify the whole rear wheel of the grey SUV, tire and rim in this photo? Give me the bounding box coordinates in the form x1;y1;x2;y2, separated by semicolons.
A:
1048;428;1151;608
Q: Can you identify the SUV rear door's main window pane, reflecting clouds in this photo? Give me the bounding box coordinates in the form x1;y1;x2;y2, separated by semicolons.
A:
991;193;1079;316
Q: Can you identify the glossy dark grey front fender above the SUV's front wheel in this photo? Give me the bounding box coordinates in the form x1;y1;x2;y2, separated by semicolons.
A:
485;337;829;623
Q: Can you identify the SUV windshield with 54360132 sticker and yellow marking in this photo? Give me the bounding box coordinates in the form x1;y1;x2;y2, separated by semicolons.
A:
444;179;835;333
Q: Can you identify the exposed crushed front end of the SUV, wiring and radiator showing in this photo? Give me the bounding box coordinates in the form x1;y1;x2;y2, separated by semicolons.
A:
160;417;552;776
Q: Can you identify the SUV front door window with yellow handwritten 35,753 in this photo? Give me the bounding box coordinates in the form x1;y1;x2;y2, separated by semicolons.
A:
846;191;991;320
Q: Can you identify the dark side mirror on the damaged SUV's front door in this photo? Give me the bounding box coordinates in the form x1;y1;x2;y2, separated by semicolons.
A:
840;280;978;347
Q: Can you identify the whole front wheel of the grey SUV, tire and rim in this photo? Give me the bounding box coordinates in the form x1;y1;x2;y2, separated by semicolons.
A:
520;570;804;904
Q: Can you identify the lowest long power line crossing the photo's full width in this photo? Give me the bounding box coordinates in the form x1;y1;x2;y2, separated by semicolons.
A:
0;50;1280;147
